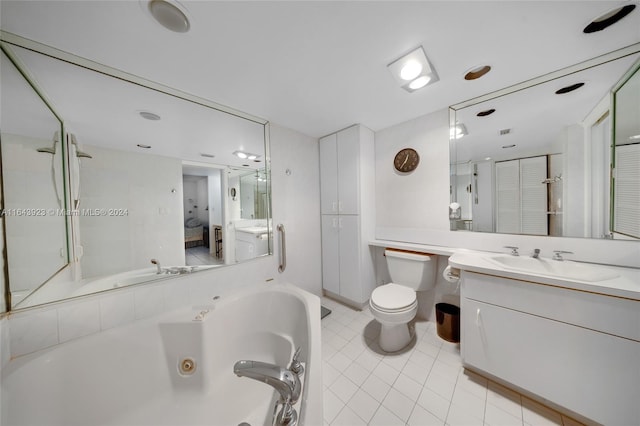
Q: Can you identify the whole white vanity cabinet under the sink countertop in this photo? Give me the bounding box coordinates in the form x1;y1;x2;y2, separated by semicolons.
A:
461;271;640;425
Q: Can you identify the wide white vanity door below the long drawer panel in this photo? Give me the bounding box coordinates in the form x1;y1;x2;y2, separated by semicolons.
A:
461;297;640;425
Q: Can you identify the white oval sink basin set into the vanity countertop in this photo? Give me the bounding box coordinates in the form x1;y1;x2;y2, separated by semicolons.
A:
488;255;619;282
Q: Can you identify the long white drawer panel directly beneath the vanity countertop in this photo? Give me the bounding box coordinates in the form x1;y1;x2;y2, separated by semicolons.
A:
461;271;640;341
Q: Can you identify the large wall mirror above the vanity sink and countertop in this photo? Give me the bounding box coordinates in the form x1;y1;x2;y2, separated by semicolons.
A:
450;44;640;239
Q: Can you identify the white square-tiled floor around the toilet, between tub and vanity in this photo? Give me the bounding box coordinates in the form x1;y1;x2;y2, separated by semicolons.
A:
322;298;580;426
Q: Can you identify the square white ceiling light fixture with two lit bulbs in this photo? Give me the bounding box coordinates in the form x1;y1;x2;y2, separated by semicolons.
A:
387;46;438;92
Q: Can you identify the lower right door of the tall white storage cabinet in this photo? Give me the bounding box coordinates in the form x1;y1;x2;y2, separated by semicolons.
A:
338;215;365;303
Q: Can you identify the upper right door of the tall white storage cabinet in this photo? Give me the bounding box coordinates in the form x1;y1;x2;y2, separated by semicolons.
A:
337;126;360;214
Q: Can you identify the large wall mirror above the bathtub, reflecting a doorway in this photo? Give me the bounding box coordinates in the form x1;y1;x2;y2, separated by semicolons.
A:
1;33;272;309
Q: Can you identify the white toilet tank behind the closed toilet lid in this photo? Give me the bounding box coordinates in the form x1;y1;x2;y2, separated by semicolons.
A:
384;249;437;291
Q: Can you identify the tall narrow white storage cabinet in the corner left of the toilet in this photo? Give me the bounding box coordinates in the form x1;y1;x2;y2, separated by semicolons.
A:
320;125;375;308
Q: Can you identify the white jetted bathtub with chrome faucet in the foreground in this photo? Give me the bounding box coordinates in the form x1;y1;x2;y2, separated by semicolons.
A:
2;284;323;426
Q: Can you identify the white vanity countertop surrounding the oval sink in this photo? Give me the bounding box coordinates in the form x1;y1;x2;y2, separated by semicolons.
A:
449;249;640;301
